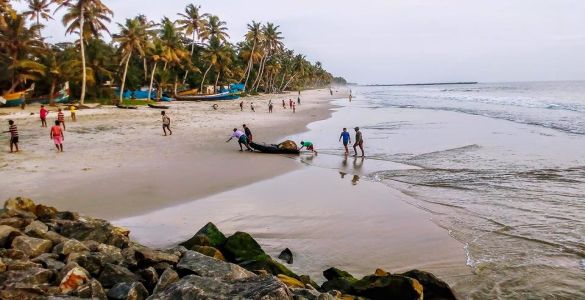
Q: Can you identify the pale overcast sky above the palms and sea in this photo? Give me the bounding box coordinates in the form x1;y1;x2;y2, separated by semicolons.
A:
11;0;585;83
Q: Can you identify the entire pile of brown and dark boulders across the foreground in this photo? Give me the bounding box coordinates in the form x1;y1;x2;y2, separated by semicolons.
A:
0;198;455;300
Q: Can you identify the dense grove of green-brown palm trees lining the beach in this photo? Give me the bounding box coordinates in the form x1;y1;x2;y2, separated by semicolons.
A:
0;0;339;104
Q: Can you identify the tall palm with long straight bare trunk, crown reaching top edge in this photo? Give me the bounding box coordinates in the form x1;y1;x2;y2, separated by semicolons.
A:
57;0;113;104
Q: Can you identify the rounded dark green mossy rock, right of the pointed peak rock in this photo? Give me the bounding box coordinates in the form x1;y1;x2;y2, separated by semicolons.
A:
223;231;266;263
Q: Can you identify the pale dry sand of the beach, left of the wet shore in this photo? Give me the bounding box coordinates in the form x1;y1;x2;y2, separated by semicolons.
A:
0;90;336;219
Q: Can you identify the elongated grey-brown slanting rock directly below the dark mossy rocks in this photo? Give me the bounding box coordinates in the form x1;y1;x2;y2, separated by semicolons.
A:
177;251;255;280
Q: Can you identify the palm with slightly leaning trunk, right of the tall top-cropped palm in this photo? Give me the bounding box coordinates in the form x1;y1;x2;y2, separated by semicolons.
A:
114;18;148;103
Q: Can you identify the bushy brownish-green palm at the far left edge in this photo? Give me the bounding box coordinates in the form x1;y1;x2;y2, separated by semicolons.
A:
0;14;44;93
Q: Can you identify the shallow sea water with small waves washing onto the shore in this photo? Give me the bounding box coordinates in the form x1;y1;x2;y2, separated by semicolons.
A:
291;82;585;299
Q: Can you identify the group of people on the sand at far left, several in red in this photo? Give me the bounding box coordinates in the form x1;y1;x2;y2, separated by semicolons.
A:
3;105;77;153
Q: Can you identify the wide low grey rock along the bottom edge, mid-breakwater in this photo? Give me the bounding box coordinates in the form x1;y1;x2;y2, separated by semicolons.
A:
152;275;292;300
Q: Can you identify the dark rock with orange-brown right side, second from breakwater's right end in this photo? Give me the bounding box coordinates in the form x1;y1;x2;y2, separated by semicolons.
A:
350;275;423;300
